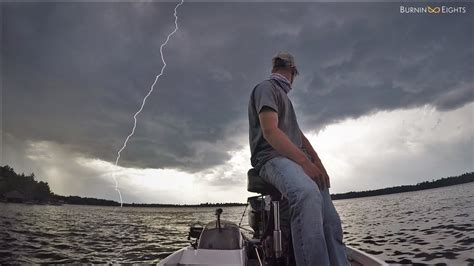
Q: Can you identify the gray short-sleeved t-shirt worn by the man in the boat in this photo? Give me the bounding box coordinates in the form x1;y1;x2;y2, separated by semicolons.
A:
248;79;303;170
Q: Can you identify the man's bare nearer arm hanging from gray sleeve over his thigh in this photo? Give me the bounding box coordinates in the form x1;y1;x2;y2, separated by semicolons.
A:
258;107;326;189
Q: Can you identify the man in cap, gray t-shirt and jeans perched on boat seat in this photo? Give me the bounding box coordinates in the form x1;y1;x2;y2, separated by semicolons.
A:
248;52;349;266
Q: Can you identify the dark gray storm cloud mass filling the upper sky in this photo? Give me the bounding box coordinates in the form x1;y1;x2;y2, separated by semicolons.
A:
2;3;473;171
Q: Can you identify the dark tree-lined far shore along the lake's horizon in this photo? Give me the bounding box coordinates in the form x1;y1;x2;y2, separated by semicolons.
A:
0;165;474;207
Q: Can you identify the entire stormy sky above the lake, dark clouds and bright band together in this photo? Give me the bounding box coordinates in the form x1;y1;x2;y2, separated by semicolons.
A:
0;1;474;203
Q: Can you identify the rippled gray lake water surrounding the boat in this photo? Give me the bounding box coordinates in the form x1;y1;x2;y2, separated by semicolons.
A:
0;183;474;265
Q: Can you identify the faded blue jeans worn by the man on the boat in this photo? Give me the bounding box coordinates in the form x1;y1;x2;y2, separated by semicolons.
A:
259;157;350;266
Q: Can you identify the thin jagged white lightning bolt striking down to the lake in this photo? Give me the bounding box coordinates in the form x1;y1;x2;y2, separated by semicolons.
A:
112;0;184;207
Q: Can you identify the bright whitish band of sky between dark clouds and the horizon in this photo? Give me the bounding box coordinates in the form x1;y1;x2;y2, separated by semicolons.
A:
17;103;474;204
